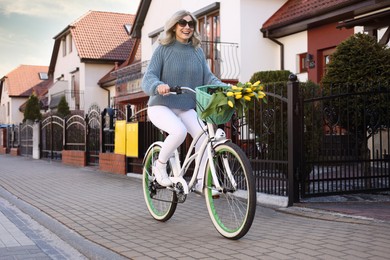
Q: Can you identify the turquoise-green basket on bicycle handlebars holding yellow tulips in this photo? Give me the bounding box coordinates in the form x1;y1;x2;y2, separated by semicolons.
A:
195;85;234;125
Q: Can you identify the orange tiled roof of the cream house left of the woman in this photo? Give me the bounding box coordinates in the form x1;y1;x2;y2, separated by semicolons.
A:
70;11;135;61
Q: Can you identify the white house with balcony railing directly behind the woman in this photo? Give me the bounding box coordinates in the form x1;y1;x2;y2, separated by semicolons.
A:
109;0;285;114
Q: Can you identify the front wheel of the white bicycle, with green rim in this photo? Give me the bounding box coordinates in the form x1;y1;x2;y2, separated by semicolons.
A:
205;142;256;239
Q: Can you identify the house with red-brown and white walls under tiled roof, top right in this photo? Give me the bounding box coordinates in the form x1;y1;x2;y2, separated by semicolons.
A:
260;0;390;83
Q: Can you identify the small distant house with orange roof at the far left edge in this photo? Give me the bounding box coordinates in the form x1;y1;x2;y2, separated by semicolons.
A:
0;65;48;124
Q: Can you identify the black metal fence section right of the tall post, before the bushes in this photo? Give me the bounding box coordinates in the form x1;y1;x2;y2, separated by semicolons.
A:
300;84;390;197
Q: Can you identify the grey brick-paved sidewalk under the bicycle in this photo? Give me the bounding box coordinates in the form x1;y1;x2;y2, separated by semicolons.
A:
0;155;390;259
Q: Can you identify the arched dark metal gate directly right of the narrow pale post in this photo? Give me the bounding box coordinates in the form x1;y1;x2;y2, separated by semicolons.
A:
41;115;65;160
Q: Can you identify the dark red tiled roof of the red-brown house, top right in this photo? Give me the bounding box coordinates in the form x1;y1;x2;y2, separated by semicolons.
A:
263;0;358;29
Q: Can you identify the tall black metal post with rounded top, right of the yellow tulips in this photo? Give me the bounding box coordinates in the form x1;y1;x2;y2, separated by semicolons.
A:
287;74;302;206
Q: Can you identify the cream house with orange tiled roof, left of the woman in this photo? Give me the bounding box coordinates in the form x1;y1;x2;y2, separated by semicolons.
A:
48;11;135;113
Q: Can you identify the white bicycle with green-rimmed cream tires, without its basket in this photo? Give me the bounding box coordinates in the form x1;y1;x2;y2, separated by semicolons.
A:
142;87;256;239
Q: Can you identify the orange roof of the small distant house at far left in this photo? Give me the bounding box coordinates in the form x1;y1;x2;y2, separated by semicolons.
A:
5;65;48;96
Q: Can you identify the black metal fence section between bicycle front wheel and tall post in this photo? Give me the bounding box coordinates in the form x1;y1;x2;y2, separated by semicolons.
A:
236;82;288;196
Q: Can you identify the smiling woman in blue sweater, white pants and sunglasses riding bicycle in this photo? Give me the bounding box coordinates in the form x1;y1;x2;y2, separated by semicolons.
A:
142;10;226;190
